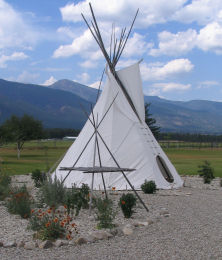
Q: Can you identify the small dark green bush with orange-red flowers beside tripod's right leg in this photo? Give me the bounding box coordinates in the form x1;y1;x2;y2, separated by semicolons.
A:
119;193;136;218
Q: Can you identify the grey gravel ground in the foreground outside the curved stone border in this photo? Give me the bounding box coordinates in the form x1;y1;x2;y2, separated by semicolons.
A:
0;177;222;260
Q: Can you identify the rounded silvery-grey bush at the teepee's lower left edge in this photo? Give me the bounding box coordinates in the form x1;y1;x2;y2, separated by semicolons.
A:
39;176;67;207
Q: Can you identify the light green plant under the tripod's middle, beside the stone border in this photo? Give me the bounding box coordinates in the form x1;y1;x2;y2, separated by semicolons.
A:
93;198;116;229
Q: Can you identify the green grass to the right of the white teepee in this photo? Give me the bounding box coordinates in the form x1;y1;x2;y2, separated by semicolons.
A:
164;148;222;177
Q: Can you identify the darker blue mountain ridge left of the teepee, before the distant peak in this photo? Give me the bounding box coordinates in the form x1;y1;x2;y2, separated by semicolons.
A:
0;79;90;129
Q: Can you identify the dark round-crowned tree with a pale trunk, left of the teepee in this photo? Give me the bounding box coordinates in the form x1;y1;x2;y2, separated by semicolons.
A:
0;115;43;159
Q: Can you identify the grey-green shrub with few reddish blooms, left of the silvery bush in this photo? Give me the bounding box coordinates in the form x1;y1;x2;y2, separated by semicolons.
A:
6;185;32;218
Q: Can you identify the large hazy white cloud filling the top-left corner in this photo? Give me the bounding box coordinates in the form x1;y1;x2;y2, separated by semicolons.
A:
0;0;38;49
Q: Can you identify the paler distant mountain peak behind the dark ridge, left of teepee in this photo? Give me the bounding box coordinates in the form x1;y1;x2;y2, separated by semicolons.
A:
49;79;98;103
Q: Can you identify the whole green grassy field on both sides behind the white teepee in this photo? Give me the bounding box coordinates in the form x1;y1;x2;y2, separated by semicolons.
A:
0;141;222;177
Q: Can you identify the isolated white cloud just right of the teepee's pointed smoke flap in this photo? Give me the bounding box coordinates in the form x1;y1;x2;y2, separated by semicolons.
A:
141;59;194;81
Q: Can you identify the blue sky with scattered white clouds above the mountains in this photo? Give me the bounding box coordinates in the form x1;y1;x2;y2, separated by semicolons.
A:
0;0;222;101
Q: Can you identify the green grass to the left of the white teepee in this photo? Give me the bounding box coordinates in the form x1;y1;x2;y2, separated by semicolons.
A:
0;141;72;175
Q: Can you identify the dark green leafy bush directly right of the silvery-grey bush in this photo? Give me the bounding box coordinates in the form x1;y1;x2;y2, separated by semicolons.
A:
65;184;89;216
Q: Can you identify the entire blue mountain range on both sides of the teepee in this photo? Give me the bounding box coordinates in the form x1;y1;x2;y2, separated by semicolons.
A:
0;80;222;134
